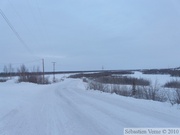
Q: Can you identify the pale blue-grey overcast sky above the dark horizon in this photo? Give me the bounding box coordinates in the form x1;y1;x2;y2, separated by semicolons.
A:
0;0;180;70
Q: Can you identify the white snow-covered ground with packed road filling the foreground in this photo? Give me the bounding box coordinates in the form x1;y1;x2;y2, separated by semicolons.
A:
0;79;180;135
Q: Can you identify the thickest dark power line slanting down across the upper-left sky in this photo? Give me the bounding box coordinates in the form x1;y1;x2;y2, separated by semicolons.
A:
0;9;32;53
